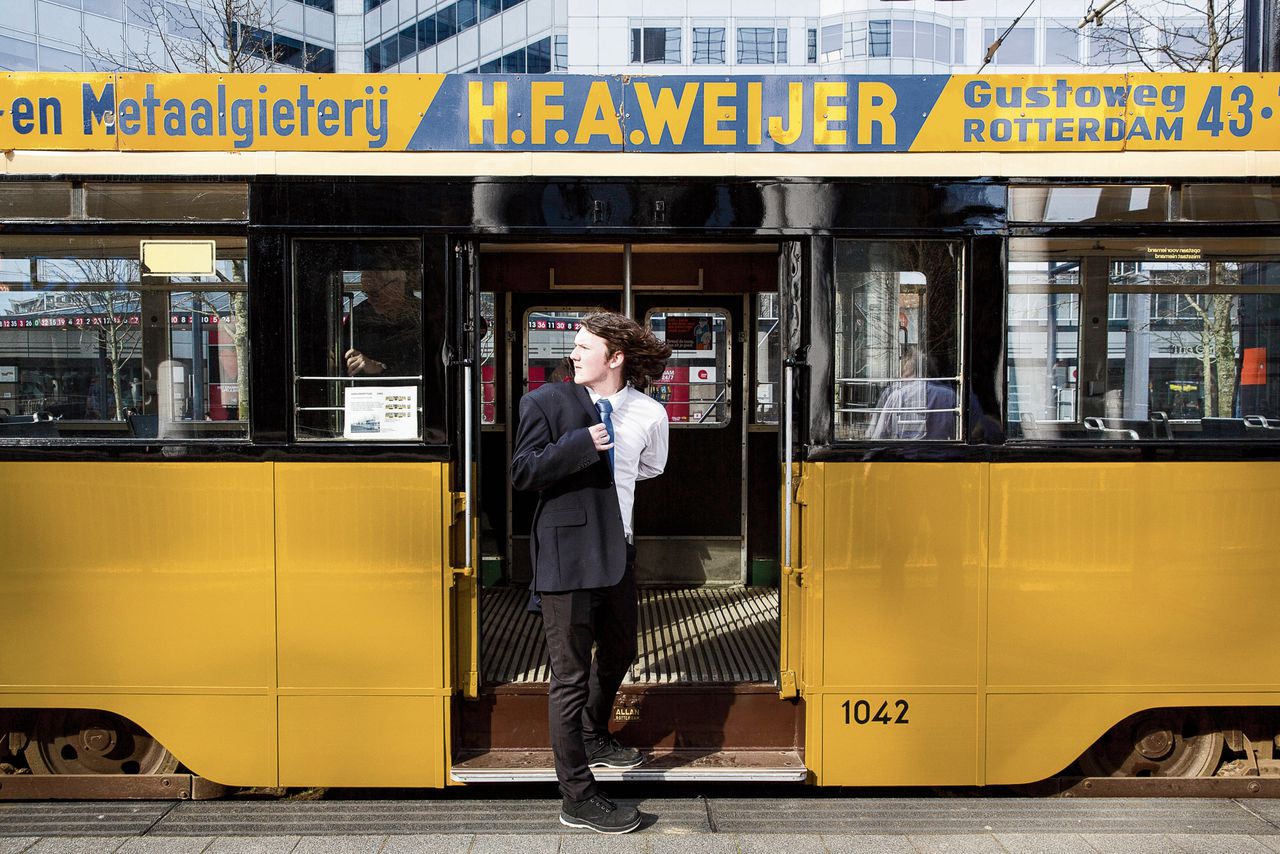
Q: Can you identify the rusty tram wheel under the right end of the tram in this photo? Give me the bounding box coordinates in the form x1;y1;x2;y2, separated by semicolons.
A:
1080;709;1222;777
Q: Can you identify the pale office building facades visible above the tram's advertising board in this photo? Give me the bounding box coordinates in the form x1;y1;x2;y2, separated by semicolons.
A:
0;0;1240;74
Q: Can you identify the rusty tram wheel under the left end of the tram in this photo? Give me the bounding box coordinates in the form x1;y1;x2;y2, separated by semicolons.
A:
23;709;178;775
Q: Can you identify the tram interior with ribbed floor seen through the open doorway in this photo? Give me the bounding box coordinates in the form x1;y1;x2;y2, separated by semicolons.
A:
479;243;780;685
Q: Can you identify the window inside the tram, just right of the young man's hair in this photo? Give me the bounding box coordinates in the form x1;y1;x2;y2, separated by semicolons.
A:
645;309;733;426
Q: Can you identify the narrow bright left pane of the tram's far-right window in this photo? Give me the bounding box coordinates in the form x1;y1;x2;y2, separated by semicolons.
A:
1006;259;1080;438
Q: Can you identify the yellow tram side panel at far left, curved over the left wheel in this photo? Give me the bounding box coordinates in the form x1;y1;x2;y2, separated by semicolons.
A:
0;462;276;785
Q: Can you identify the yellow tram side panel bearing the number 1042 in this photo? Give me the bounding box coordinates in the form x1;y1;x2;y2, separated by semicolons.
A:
803;462;988;785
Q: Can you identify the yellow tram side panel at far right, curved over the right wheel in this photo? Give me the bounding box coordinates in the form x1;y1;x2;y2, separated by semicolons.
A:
987;462;1280;784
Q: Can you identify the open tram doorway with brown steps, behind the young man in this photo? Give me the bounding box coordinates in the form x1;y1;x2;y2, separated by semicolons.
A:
453;242;804;780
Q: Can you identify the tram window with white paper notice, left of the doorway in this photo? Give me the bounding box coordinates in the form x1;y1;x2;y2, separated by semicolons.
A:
293;239;432;442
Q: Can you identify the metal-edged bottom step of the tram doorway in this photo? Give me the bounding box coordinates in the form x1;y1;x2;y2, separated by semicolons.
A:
449;750;809;782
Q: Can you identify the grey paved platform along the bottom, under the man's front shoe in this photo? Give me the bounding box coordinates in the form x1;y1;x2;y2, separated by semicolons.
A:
0;793;1280;854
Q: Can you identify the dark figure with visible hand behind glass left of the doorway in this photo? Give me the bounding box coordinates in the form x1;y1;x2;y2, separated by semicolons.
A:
343;270;422;376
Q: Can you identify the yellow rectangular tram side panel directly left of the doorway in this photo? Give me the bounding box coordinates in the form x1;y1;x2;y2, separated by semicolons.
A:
276;462;452;786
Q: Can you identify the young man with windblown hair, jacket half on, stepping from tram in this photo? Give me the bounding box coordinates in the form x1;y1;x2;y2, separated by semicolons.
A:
511;312;671;834
